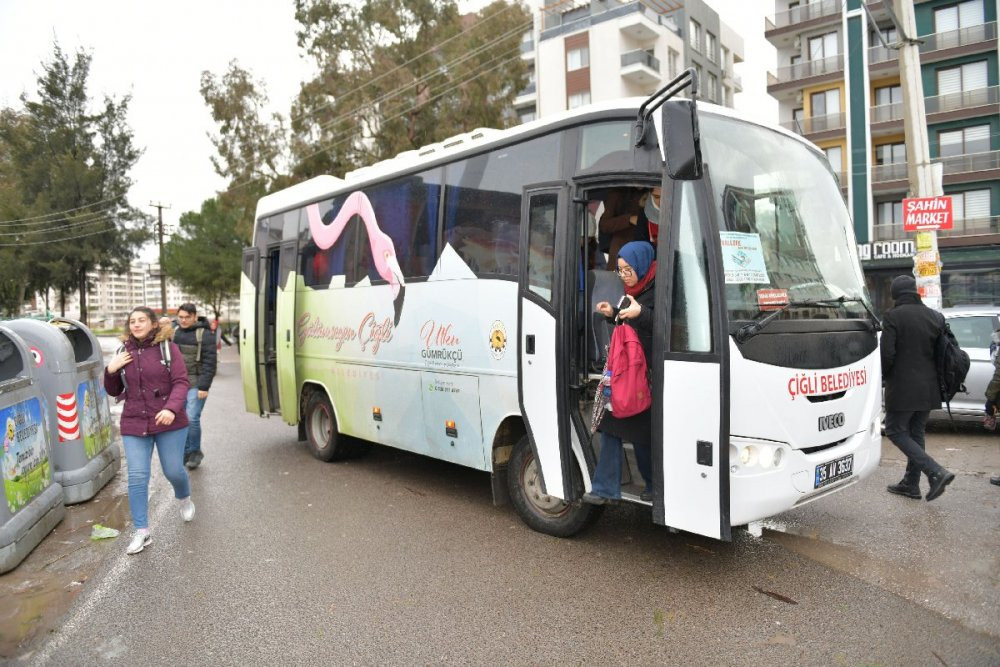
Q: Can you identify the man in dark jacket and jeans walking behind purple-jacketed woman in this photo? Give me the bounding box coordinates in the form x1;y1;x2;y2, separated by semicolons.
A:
174;303;216;470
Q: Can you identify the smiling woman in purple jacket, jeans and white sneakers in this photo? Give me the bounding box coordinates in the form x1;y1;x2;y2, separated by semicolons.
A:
104;307;194;554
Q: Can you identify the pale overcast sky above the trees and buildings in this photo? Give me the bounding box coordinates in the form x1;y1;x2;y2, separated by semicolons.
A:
0;0;777;257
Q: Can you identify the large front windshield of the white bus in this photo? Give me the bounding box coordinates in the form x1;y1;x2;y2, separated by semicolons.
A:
699;114;868;320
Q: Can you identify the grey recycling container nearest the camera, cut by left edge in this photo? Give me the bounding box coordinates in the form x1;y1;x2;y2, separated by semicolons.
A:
0;325;66;573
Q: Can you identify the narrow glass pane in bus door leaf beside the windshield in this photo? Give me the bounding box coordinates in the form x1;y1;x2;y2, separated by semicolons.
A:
670;181;712;352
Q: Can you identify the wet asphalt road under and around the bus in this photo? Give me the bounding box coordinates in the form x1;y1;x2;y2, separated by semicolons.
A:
7;349;1000;665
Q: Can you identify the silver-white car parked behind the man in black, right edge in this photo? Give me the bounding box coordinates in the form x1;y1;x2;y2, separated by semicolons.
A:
931;306;1000;420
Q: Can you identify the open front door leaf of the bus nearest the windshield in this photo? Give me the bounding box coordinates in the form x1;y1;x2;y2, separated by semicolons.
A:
652;95;730;540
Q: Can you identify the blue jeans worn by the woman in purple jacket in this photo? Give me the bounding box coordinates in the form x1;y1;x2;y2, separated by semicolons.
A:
122;428;191;529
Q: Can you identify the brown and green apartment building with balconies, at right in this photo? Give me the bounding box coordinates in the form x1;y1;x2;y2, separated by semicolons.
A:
764;0;1000;310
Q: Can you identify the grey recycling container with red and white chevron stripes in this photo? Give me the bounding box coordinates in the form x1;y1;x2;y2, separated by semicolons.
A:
7;318;121;505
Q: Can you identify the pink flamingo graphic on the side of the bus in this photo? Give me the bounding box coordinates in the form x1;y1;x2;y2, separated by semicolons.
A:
306;191;406;325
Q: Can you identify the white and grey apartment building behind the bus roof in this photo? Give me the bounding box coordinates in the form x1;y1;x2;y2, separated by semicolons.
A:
514;0;743;122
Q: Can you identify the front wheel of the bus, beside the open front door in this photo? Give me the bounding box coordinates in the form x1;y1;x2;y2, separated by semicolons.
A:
507;434;604;537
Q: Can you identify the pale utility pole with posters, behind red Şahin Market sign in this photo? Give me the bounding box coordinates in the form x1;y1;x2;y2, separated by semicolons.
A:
893;0;944;310
